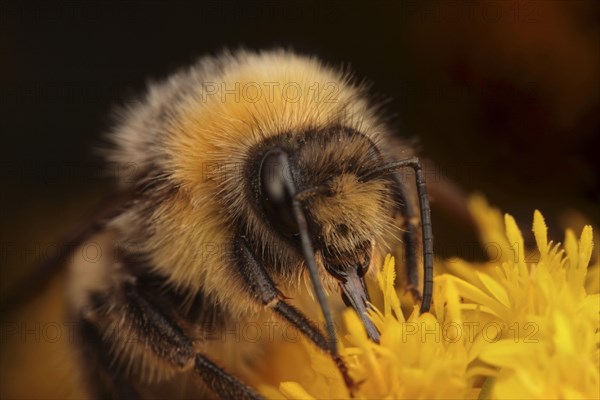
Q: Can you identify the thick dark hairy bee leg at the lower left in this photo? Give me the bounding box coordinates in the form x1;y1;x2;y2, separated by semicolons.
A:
81;283;262;400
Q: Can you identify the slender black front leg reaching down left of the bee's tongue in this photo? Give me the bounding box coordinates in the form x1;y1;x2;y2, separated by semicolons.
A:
234;236;356;395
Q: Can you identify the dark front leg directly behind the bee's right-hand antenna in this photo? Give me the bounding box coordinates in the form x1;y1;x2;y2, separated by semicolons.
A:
393;172;421;301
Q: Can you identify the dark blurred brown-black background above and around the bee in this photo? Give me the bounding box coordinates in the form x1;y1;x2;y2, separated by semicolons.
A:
0;0;600;397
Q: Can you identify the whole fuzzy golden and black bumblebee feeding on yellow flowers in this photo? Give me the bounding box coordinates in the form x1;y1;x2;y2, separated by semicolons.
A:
3;50;433;399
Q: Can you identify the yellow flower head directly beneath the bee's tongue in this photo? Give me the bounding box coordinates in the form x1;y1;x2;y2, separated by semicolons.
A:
265;256;476;399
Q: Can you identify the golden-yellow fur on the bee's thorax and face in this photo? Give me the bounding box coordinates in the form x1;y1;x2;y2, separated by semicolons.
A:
104;51;404;315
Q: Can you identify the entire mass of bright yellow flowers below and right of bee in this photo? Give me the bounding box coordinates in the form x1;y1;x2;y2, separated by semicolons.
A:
262;197;600;399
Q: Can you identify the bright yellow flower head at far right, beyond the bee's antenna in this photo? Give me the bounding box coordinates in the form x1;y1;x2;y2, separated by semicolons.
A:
438;198;600;399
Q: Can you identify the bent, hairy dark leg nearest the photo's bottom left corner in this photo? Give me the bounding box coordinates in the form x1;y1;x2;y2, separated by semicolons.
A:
77;283;262;400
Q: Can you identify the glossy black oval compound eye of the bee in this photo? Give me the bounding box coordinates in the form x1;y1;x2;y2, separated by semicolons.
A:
259;149;299;236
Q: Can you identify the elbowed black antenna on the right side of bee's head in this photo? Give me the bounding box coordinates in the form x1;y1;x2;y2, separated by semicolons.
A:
360;157;433;314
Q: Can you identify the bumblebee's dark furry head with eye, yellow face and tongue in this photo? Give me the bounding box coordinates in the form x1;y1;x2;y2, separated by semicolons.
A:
257;127;393;339
